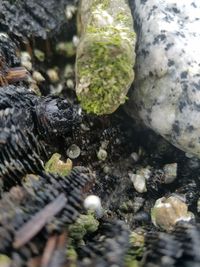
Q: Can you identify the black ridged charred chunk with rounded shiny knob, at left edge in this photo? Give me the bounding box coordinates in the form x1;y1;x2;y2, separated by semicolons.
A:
0;85;82;186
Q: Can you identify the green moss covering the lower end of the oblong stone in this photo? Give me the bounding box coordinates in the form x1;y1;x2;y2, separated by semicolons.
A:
77;30;134;115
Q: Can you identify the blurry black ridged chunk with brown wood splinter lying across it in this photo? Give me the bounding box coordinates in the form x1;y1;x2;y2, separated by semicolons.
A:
0;167;94;255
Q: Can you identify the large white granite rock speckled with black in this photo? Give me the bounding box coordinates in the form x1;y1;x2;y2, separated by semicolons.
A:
128;0;200;157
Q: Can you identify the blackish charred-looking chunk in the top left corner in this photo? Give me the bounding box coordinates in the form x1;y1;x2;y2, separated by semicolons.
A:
0;0;75;39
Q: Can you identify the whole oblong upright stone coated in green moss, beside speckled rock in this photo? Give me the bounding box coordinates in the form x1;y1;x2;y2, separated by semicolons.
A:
76;0;136;115
